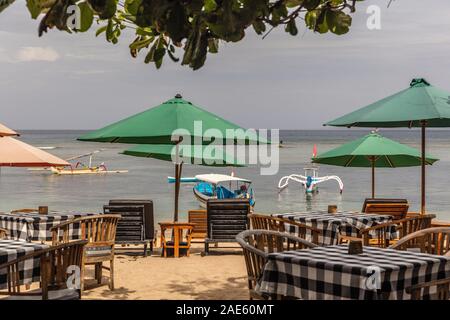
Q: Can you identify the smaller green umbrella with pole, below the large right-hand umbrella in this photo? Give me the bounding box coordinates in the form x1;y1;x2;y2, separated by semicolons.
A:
312;132;438;198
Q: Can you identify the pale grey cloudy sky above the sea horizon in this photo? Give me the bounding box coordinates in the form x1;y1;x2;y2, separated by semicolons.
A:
0;0;450;130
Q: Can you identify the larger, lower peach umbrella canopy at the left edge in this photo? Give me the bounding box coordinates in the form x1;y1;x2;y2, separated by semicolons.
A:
0;137;70;167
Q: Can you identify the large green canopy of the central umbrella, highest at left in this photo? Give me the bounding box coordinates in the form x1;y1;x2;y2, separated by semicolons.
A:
78;95;267;144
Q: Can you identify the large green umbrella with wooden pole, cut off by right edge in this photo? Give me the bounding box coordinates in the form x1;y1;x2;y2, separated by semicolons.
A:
325;78;450;213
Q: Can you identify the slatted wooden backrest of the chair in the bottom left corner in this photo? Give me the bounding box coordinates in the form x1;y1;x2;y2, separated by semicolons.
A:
0;240;87;300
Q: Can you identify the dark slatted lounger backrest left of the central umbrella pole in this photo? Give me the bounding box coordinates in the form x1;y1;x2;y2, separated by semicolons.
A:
103;205;145;243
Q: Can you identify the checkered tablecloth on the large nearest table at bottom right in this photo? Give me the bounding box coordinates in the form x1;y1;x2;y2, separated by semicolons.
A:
256;245;450;300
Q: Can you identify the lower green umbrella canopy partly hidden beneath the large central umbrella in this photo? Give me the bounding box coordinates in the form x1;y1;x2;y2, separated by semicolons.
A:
122;144;243;167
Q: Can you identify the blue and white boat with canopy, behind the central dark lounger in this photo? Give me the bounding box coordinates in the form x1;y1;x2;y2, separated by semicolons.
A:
193;174;255;209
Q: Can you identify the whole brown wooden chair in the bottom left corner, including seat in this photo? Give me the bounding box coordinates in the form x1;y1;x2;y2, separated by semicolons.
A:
0;240;87;300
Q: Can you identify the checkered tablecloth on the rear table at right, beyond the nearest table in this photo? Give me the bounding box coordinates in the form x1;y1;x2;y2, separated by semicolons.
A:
272;211;398;246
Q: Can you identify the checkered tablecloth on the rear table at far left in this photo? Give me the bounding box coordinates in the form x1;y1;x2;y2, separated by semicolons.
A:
0;212;96;241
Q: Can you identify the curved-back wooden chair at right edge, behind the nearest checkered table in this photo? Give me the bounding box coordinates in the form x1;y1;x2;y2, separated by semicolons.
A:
389;227;450;256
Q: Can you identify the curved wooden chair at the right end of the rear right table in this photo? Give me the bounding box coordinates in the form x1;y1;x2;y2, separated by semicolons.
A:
358;214;436;248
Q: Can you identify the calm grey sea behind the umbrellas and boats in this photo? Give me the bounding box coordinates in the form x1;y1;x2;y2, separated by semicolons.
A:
0;129;450;221
